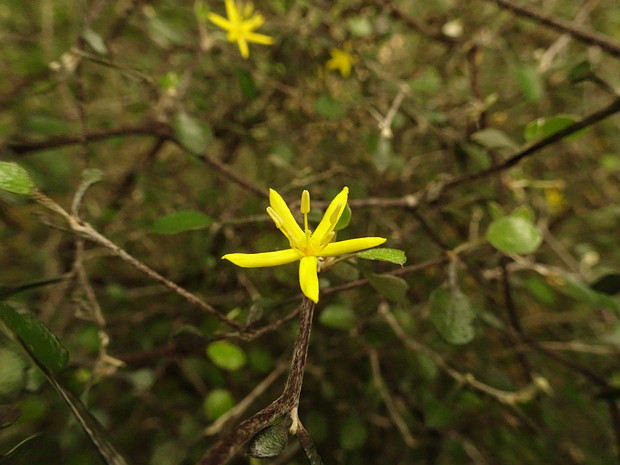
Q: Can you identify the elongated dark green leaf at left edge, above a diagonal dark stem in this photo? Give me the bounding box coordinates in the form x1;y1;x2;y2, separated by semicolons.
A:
0;302;69;373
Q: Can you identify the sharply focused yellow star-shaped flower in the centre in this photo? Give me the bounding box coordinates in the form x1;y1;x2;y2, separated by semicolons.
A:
222;187;386;303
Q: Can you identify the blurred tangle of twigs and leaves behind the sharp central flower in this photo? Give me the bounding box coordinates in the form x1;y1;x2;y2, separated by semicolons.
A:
0;0;620;465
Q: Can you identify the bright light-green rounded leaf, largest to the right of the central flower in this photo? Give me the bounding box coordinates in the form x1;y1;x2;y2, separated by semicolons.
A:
486;216;542;254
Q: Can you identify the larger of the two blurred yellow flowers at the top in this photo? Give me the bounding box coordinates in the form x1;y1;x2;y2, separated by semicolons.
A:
207;0;273;58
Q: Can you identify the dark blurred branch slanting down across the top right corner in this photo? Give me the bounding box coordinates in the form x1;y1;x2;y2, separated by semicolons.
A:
487;0;620;58
